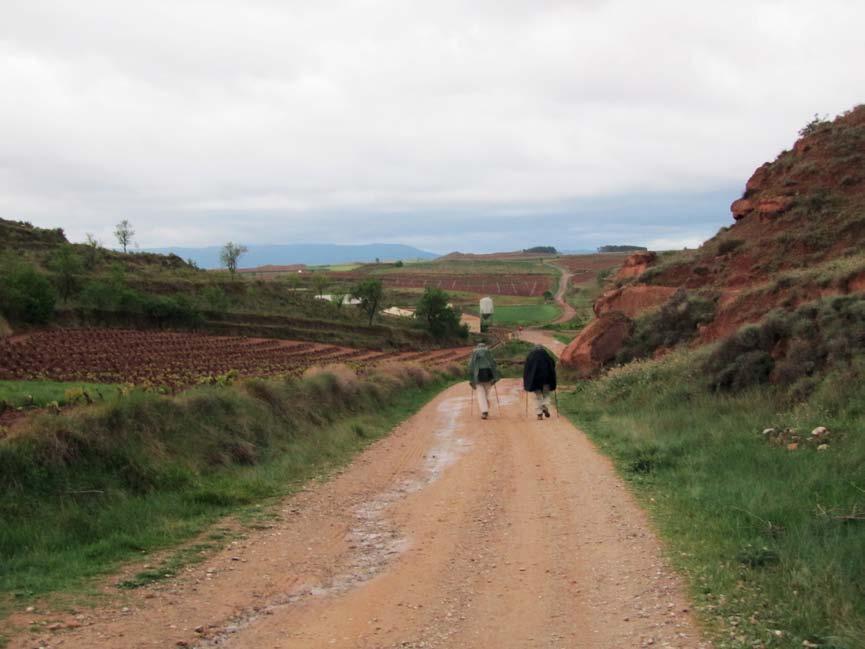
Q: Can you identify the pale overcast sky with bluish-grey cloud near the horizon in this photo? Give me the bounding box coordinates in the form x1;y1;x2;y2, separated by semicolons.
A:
0;0;865;252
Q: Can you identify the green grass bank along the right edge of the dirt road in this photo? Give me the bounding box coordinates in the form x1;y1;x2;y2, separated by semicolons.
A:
561;353;865;649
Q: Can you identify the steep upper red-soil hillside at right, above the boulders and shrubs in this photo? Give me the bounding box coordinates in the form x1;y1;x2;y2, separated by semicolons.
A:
641;106;865;289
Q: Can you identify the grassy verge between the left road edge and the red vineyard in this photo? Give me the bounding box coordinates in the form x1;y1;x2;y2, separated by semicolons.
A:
0;367;454;616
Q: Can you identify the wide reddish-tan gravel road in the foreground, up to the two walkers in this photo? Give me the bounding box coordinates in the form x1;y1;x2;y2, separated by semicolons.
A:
10;380;708;649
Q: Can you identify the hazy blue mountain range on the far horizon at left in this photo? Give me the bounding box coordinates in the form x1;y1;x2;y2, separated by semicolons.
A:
145;243;438;268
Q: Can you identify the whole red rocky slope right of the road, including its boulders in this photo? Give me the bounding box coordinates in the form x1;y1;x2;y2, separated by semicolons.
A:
562;105;865;374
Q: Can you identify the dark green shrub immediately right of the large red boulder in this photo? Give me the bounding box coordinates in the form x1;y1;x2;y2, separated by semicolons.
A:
617;289;715;363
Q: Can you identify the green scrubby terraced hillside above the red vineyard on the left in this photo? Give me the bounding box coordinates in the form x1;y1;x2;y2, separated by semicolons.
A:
0;219;459;349
